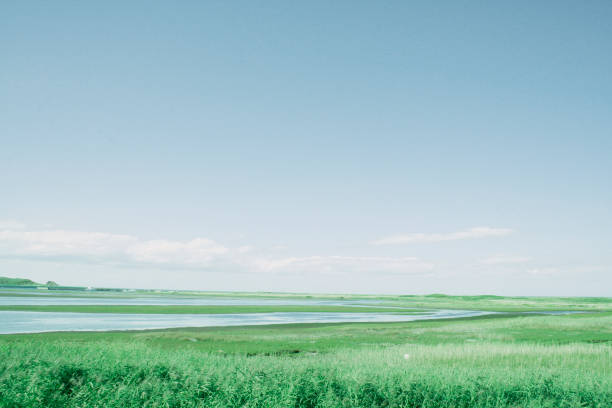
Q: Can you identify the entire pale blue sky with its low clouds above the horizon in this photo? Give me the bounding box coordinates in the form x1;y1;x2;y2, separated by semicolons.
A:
0;1;612;296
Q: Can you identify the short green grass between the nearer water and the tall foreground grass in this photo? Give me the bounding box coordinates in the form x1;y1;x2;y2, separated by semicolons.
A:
0;313;612;355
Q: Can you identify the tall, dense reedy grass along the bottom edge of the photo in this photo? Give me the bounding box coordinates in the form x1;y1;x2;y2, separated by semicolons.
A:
0;338;612;408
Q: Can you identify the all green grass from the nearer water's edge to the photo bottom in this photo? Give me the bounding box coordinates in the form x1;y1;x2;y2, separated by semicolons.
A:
0;313;612;408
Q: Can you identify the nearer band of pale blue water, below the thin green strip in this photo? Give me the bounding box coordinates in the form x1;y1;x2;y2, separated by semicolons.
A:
0;310;491;334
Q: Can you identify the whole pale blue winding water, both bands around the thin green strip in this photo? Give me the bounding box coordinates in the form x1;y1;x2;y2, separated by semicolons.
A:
0;291;502;334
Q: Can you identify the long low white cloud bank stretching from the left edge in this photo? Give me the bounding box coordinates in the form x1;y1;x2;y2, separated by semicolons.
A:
0;223;434;275
